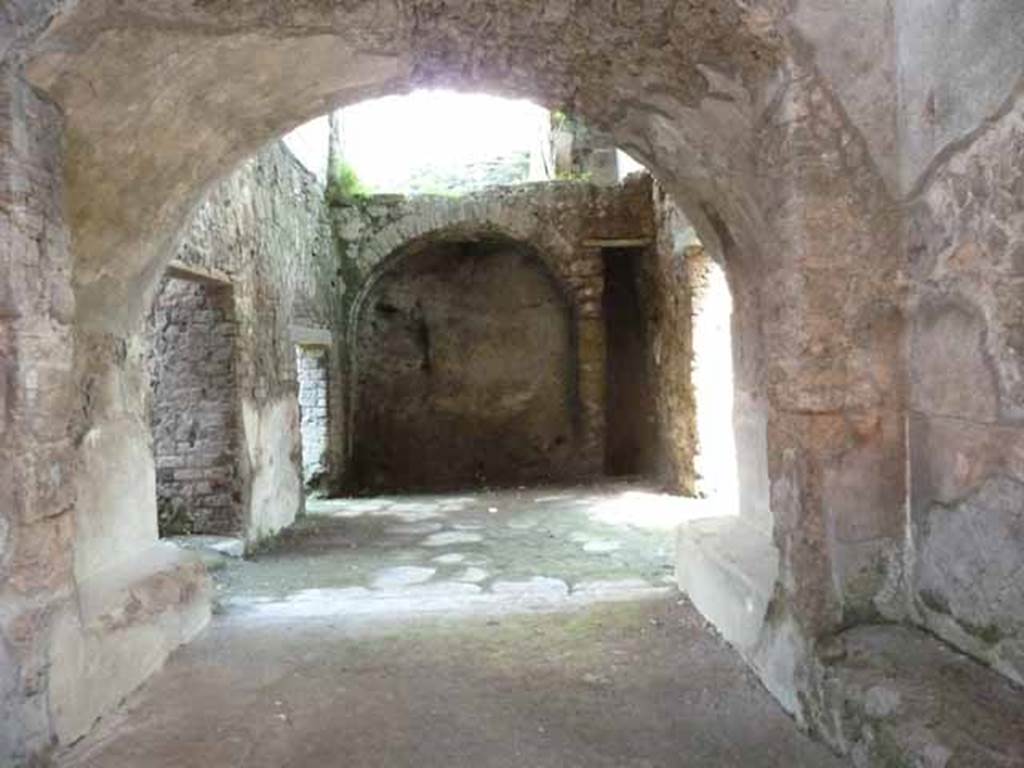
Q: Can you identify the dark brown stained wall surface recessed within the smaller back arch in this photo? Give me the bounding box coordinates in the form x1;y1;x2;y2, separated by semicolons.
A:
354;240;579;492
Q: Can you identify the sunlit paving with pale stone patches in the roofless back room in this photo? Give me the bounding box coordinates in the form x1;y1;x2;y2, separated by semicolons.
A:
212;482;714;620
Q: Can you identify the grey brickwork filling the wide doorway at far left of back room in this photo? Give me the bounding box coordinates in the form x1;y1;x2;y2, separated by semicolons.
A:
148;278;242;536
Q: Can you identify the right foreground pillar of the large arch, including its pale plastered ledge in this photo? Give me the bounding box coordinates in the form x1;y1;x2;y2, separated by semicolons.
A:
677;61;906;727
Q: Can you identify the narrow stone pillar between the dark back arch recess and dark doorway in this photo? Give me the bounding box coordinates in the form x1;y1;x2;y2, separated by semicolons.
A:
567;248;606;476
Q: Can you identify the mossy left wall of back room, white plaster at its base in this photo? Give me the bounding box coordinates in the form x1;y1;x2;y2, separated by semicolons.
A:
177;143;344;542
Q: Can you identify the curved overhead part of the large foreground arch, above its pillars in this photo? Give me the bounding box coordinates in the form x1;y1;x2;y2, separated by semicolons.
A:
27;0;785;331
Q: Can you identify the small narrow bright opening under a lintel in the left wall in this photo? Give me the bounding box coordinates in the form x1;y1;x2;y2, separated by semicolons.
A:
295;344;330;490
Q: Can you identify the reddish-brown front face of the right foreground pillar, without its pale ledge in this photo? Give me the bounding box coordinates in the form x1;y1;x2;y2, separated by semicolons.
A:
759;67;906;640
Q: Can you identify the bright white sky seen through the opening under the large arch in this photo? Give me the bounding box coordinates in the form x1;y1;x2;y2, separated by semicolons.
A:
285;90;549;191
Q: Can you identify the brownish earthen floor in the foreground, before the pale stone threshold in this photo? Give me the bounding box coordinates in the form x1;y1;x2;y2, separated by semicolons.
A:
59;595;842;768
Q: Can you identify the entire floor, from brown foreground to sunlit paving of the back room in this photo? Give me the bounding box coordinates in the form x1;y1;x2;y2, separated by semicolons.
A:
61;485;840;768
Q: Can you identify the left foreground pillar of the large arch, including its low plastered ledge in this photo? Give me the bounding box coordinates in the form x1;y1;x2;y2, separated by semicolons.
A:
0;70;209;765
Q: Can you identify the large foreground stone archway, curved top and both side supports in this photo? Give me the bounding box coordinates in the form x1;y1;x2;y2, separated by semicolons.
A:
0;0;904;757
